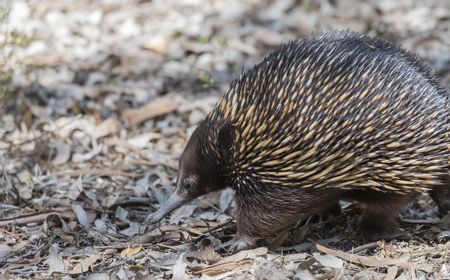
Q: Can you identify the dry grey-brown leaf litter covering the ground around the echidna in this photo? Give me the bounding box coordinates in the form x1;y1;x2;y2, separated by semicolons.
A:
0;0;450;280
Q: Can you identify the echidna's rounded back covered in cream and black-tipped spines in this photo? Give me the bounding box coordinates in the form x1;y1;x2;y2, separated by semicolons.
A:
213;31;449;193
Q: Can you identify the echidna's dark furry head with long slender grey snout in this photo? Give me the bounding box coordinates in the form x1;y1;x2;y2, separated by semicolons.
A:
147;121;230;225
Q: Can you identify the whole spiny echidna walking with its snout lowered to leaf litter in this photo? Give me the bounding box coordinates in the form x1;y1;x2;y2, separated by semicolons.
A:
147;31;450;252
